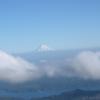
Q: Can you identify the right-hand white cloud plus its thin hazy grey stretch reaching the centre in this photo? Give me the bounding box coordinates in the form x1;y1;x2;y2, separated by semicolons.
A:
37;51;100;80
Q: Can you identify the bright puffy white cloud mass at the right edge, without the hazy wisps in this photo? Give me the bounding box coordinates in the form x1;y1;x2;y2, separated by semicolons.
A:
73;51;100;79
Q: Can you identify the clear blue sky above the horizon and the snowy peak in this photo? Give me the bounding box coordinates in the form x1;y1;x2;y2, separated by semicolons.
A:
0;0;100;52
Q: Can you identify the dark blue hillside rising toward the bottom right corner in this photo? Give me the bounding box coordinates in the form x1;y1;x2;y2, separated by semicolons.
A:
32;90;100;100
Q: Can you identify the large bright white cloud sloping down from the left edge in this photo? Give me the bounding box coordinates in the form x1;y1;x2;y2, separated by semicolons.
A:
0;51;39;82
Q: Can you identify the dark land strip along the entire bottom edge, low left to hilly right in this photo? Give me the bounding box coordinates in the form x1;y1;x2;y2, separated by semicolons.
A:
0;89;100;100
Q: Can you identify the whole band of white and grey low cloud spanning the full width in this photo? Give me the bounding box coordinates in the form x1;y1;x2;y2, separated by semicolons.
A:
0;51;100;83
